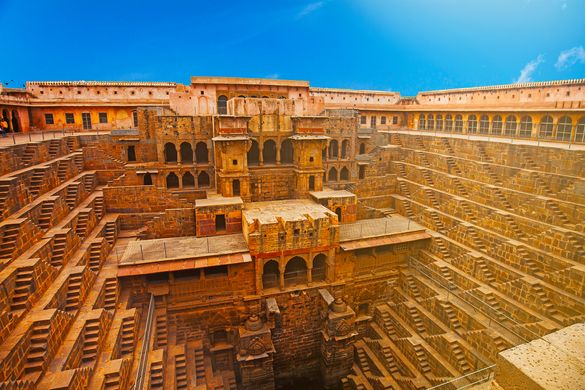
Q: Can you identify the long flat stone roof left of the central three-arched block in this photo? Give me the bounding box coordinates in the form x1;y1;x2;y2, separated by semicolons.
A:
118;233;248;267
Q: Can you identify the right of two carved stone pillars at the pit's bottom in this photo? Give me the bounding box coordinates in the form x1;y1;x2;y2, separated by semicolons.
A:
321;298;358;389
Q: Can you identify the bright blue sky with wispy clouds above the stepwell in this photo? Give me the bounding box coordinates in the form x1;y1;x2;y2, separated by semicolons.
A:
0;0;585;95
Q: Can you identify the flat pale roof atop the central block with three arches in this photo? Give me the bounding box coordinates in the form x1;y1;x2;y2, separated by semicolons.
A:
243;199;334;224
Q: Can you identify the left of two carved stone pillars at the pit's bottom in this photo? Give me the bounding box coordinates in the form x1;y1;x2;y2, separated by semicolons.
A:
236;315;276;390
